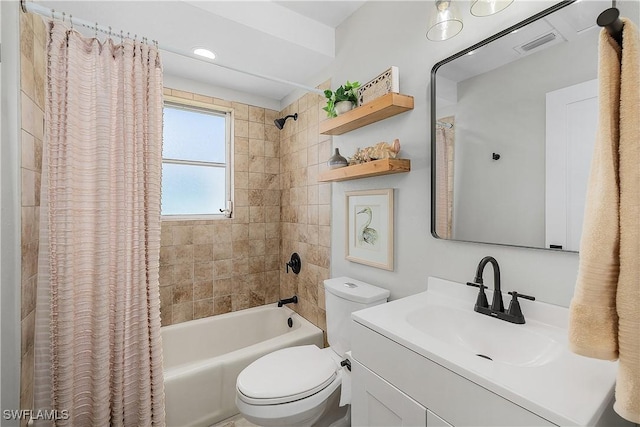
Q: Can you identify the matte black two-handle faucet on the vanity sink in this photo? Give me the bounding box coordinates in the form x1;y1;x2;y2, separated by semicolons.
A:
467;256;535;324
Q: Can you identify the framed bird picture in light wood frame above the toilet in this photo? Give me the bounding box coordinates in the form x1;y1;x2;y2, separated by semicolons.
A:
345;188;393;271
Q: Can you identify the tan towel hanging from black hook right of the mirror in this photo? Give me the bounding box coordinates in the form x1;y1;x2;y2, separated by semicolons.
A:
569;18;640;423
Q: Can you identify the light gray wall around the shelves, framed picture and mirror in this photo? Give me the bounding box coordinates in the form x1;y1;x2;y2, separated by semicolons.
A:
330;1;628;306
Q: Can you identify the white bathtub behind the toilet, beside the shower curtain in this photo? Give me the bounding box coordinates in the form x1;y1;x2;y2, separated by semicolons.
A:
161;304;323;427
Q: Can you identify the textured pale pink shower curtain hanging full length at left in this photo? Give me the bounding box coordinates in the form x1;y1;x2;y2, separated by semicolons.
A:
34;22;164;426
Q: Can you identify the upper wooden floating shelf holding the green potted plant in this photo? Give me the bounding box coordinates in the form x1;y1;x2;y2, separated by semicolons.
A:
320;92;413;135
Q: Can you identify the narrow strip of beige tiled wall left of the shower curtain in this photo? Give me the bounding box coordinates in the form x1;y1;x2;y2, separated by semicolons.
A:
20;13;46;424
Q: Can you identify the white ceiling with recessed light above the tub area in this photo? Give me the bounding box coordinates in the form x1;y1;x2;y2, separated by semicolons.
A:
36;0;366;101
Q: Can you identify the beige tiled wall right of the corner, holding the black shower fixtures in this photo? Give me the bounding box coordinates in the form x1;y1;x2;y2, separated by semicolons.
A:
280;82;332;338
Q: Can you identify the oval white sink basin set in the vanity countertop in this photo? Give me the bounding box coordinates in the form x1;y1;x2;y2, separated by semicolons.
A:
406;304;561;367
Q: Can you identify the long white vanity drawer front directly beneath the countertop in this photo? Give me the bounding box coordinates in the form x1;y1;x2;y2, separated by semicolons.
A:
351;321;555;427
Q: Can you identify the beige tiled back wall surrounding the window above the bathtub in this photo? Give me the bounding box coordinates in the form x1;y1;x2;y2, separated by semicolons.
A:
160;89;284;325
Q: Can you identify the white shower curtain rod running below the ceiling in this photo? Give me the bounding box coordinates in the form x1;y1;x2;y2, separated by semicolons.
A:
20;0;324;95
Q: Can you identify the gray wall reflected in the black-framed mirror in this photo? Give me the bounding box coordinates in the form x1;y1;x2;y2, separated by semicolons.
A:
453;28;599;247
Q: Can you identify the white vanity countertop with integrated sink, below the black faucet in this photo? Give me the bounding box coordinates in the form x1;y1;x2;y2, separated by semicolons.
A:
352;277;617;425
